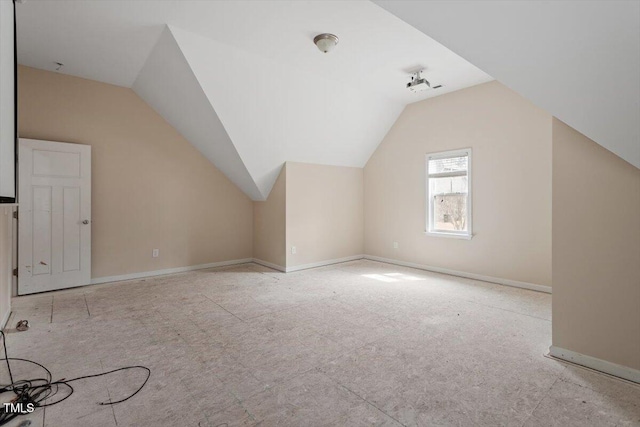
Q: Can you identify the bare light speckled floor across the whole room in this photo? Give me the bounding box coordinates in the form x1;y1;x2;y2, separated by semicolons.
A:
0;261;640;427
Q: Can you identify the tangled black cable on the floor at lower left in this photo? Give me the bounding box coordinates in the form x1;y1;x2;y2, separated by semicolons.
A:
0;330;151;426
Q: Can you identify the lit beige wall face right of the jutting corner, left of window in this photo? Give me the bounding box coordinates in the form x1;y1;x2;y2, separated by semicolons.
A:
286;162;364;267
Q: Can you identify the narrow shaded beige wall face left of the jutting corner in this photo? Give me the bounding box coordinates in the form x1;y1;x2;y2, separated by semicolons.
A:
253;165;287;269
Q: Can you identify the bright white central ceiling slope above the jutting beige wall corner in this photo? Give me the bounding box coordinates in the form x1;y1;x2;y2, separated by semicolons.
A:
162;27;405;201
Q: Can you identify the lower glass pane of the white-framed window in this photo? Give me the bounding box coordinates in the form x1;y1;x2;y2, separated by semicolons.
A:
429;176;468;231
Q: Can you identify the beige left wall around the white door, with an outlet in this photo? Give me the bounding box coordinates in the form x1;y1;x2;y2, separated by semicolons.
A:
18;66;253;278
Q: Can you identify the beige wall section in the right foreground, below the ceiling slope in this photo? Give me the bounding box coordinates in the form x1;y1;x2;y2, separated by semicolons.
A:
553;119;640;369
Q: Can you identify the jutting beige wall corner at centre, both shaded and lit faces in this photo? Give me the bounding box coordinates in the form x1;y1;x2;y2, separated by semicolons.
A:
253;162;364;271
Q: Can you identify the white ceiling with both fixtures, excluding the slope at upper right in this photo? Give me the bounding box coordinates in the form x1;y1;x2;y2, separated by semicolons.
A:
17;0;491;200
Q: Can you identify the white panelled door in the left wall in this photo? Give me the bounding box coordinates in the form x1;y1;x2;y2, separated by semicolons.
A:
18;139;91;295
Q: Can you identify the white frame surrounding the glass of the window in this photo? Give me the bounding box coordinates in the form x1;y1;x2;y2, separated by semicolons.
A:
425;148;473;240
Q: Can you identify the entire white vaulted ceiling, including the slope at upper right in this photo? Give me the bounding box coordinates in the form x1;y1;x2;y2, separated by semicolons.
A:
16;0;640;200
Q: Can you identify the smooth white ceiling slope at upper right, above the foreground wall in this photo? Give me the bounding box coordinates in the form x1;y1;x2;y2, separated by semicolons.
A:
374;0;640;168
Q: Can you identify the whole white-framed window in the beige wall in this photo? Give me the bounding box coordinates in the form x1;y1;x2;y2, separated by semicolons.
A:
427;148;472;239
